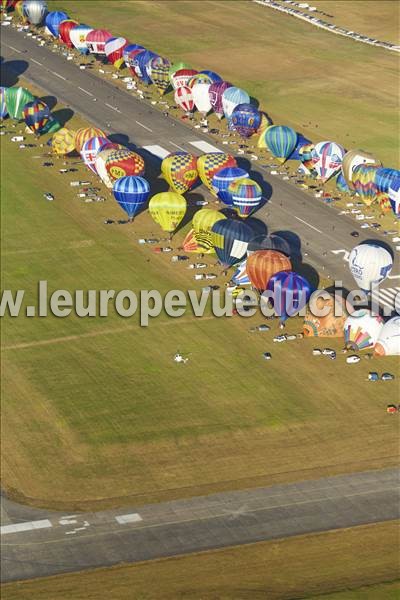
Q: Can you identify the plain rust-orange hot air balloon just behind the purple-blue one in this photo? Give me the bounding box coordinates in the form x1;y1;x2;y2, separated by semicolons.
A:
246;250;292;292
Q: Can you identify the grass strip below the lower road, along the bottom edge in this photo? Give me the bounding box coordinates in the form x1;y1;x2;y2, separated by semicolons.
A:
2;522;399;600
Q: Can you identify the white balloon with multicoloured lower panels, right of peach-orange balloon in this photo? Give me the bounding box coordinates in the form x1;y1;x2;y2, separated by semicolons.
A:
344;310;383;351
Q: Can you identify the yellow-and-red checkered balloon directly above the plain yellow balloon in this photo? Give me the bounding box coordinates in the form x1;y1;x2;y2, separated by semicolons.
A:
161;152;198;194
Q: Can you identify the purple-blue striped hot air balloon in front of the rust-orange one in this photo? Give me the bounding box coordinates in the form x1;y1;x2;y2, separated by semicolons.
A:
267;271;312;322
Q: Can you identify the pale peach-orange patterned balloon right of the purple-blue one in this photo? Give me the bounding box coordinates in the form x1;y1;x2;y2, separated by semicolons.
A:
303;294;348;338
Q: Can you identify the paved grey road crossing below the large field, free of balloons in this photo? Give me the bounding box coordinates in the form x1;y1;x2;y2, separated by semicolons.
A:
1;469;400;582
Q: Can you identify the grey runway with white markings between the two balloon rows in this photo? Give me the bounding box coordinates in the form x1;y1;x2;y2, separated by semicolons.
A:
1;27;400;310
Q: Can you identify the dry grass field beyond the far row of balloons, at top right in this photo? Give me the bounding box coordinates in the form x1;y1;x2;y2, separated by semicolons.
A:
50;0;400;167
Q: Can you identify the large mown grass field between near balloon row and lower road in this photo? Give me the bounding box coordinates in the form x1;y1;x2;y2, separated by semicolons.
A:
2;88;399;509
